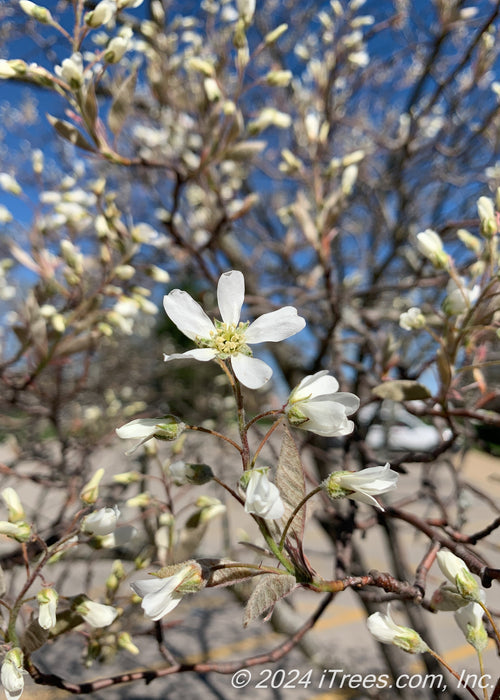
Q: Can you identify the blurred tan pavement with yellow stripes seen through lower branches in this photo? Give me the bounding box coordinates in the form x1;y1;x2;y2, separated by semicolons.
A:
1;442;500;700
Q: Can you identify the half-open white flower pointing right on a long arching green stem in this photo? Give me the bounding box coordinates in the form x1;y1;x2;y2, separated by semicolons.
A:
323;463;398;510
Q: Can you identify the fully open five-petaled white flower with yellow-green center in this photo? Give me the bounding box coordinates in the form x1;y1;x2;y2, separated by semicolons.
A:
163;270;305;389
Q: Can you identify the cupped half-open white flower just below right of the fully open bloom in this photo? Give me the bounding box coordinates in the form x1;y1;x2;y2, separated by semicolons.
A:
285;370;359;437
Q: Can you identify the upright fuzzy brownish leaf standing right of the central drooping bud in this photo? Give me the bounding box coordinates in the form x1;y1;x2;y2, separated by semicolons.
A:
276;428;306;542
